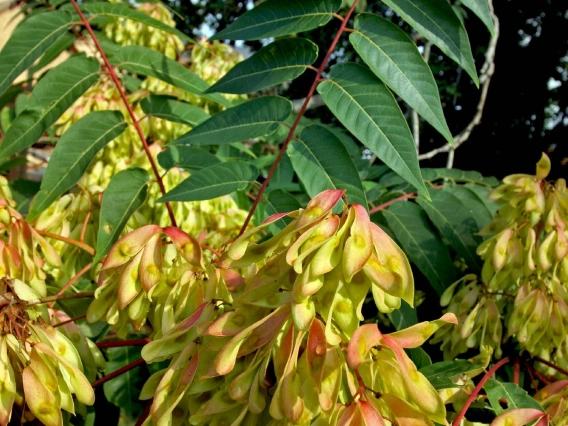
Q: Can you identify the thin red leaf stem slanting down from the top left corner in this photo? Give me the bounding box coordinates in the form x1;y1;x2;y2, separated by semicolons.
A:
71;0;177;227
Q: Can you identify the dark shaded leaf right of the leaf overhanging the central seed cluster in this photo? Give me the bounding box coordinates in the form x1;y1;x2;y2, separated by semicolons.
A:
417;190;480;268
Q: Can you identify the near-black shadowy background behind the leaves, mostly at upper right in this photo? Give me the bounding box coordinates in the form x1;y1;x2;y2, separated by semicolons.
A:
169;0;568;178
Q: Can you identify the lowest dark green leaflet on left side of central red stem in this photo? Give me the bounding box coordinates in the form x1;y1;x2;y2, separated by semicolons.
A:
157;161;258;203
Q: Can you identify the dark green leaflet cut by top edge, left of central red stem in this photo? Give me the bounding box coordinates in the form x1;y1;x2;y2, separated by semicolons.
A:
211;0;341;40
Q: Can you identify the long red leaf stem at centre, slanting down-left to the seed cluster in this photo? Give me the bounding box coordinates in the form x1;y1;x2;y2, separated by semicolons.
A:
239;0;359;236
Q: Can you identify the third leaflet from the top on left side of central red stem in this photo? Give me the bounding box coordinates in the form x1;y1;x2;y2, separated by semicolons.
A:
171;96;292;145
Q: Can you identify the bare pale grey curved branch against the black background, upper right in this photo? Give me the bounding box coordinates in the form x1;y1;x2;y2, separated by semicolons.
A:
418;1;499;161
